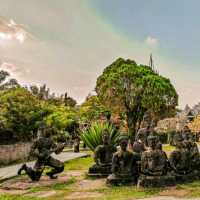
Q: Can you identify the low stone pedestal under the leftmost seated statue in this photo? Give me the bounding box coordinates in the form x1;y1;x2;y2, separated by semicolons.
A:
88;165;111;178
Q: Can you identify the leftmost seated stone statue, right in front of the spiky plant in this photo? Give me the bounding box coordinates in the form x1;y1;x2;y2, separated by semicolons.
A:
88;130;116;177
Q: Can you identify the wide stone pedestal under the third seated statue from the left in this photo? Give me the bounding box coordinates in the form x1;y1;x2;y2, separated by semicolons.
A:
137;175;176;187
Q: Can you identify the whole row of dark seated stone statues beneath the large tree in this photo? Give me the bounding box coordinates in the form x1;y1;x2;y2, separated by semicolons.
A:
88;127;200;187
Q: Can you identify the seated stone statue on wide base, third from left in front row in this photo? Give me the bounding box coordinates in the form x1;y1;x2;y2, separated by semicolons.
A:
138;135;175;187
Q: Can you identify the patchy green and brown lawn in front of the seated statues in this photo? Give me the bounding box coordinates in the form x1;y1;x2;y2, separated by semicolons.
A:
0;146;200;200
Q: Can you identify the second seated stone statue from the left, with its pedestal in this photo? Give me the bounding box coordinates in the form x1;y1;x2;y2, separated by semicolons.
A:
107;136;140;185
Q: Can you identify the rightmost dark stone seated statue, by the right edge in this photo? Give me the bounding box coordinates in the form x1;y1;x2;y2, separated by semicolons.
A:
169;134;199;183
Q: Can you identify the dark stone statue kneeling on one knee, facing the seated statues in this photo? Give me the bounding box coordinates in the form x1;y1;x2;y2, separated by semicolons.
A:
18;127;64;181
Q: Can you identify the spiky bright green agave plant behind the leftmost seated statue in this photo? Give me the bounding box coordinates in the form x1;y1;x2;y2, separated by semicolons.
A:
81;122;120;151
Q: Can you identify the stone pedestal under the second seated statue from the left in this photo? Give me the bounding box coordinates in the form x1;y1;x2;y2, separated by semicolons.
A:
106;174;137;186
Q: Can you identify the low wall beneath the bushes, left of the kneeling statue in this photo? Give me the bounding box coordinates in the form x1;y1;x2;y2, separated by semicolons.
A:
0;143;32;165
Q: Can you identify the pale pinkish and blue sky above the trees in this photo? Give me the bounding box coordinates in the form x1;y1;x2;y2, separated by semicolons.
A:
0;0;200;107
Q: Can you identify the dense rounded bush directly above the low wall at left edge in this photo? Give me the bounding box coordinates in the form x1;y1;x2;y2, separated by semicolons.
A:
0;87;47;142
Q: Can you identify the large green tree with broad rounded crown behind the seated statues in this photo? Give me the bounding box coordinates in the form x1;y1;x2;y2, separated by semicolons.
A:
96;58;178;140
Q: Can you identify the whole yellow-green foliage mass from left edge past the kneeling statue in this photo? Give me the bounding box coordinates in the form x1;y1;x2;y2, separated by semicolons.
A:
0;87;78;144
